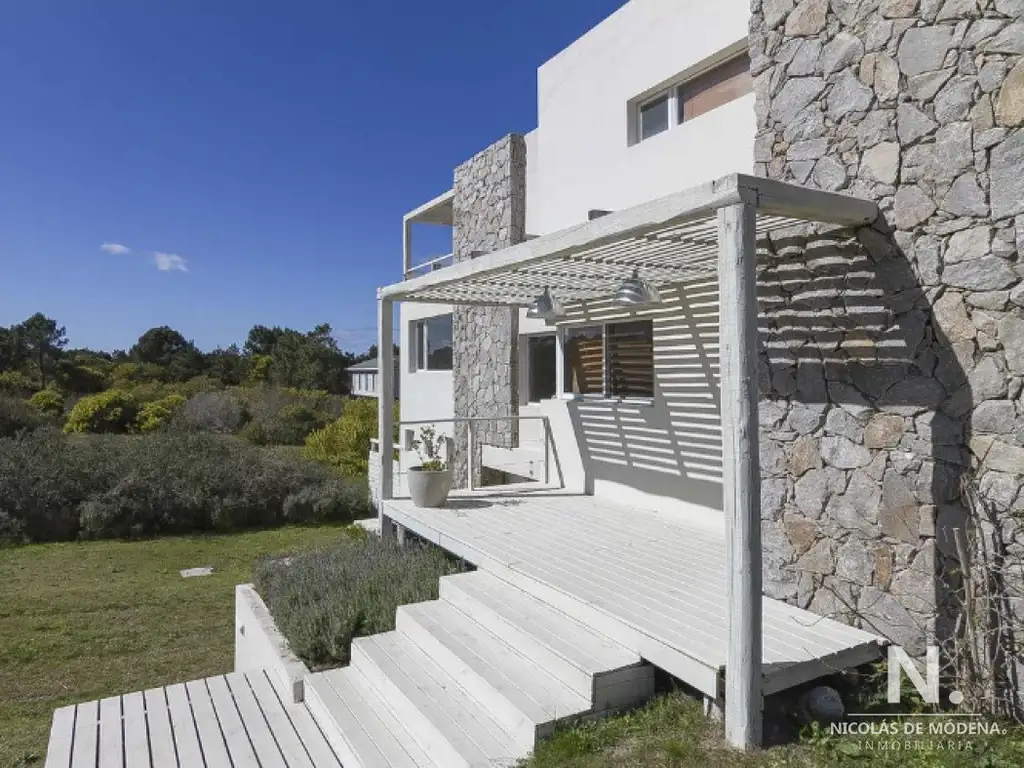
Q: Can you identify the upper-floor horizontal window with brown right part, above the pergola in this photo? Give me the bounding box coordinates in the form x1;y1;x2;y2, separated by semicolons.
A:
632;53;754;143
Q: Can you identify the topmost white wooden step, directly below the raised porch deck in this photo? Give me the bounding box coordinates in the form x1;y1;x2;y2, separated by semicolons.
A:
440;570;653;711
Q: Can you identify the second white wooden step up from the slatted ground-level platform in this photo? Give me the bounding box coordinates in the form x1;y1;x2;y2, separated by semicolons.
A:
354;632;534;768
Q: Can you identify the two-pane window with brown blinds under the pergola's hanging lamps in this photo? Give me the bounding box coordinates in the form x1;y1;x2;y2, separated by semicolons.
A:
564;321;654;397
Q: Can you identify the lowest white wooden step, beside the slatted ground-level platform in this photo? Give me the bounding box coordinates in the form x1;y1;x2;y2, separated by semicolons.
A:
305;667;434;768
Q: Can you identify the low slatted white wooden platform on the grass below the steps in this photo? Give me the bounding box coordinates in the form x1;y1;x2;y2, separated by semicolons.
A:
46;672;341;768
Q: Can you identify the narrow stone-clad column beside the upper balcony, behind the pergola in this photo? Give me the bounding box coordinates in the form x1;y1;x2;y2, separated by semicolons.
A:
453;134;526;485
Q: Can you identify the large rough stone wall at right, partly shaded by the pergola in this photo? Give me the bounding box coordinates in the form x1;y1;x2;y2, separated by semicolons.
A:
751;0;1024;651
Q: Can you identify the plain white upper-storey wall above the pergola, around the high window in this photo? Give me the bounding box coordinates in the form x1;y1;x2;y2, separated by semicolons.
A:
526;0;756;234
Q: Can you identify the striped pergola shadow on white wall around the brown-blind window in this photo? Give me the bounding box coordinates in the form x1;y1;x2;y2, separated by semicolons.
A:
567;281;722;509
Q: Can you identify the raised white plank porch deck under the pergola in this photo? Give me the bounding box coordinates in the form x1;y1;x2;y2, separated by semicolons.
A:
384;486;884;698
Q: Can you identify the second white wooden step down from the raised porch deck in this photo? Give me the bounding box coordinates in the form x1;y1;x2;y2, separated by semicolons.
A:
396;600;591;743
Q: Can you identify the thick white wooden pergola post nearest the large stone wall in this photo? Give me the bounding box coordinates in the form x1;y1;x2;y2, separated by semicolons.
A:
718;204;763;750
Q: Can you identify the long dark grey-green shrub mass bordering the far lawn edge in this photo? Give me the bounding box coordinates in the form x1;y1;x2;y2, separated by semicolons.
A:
0;429;370;541
